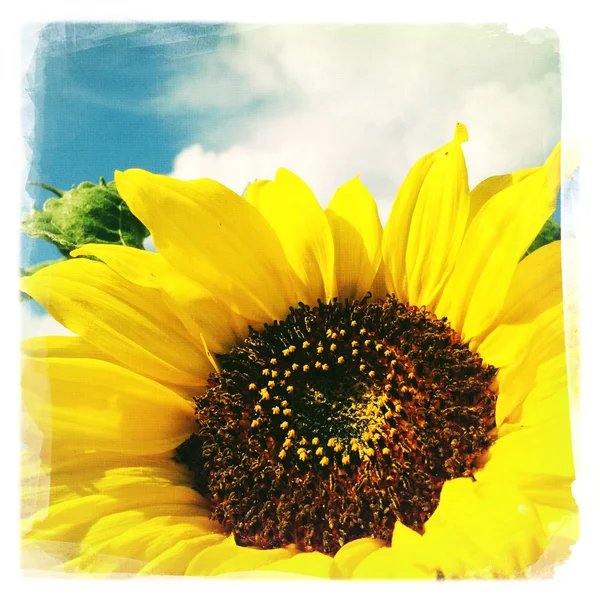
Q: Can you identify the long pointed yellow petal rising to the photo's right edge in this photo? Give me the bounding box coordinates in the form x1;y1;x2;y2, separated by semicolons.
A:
437;140;560;339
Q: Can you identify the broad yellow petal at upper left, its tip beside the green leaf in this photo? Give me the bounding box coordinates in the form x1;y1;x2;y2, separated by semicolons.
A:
115;169;295;323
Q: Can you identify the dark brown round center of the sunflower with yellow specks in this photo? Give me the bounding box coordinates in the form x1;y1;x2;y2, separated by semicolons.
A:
177;296;496;554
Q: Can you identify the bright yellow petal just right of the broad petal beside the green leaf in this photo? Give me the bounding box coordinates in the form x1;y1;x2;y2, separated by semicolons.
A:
247;169;336;304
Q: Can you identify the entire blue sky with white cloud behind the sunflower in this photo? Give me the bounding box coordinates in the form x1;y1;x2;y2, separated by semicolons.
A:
22;22;561;330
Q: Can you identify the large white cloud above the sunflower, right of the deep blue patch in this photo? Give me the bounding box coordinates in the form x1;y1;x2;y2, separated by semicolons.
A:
163;25;560;219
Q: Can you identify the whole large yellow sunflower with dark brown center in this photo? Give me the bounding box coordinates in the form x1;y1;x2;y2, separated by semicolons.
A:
22;124;577;579
